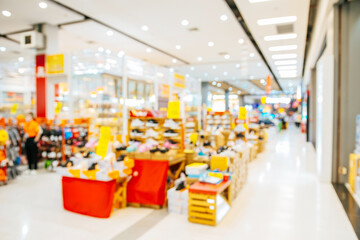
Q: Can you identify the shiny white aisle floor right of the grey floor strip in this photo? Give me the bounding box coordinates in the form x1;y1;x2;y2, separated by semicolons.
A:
131;128;357;240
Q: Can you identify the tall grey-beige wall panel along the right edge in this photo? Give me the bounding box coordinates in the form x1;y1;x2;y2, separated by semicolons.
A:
332;1;360;183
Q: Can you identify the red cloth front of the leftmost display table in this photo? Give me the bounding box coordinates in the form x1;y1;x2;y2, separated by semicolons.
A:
62;177;116;218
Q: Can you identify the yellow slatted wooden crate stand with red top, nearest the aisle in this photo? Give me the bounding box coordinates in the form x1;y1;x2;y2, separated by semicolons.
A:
188;181;231;226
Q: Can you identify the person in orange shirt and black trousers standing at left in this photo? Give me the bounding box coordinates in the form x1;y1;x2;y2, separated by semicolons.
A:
24;113;42;175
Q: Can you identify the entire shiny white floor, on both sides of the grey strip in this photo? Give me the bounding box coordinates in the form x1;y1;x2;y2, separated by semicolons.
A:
0;128;357;240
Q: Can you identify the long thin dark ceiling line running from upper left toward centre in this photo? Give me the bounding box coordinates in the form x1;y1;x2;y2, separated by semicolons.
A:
48;0;190;65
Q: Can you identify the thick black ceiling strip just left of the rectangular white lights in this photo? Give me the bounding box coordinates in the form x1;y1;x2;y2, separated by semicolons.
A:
224;0;283;91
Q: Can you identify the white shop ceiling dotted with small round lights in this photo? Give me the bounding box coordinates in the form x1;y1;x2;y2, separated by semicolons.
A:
0;0;308;94
